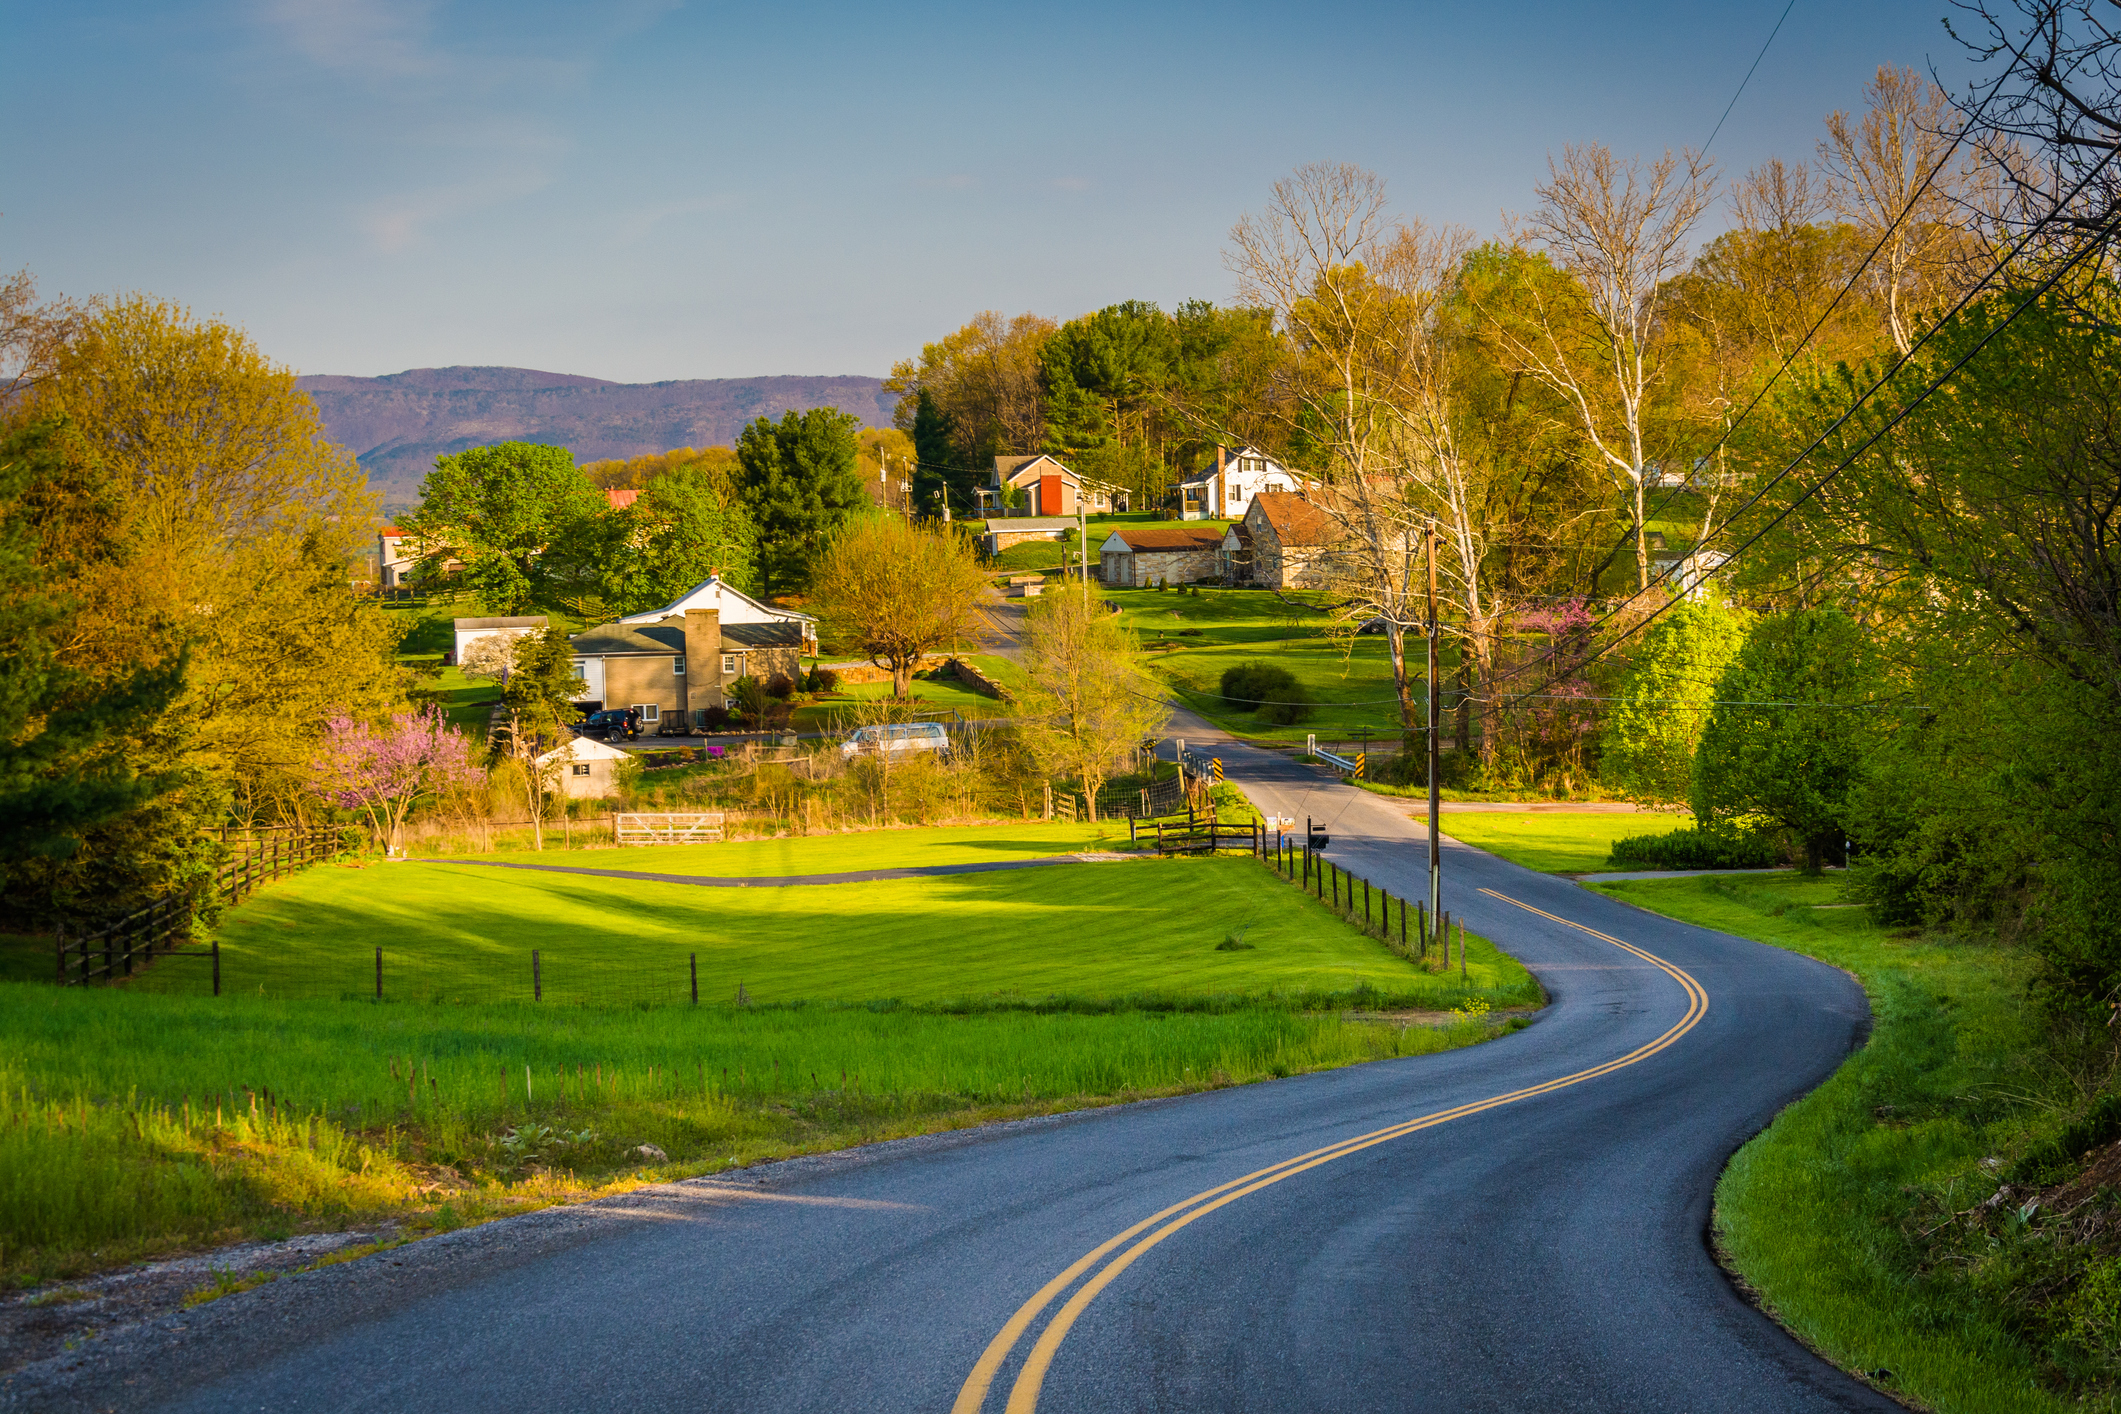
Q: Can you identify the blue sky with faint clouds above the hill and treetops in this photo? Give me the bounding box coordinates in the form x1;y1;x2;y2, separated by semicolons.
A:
0;0;1964;382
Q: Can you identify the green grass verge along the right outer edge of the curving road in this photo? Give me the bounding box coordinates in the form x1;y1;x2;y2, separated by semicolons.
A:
1595;873;2070;1414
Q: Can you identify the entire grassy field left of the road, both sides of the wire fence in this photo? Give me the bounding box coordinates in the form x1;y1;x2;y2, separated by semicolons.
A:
0;825;1538;1283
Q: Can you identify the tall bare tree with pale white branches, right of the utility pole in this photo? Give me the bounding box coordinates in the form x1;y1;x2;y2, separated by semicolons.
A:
1497;144;1716;587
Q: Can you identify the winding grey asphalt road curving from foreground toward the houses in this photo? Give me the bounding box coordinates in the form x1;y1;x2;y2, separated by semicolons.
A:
15;748;1898;1414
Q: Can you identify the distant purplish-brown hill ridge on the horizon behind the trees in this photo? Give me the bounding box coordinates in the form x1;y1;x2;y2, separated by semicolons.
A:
297;369;891;507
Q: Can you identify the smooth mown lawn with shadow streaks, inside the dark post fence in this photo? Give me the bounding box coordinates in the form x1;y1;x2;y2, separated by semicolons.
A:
134;835;1527;1007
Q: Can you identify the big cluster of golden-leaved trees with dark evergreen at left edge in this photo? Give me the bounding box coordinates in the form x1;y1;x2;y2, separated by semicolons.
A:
0;288;409;933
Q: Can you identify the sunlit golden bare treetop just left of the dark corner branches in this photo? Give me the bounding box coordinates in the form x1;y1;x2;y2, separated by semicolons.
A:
1820;64;1970;354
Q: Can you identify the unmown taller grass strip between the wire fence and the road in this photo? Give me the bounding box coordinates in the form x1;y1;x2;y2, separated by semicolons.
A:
0;984;1493;1283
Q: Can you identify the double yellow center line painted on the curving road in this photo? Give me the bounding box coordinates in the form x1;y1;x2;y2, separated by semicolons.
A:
950;888;1710;1414
